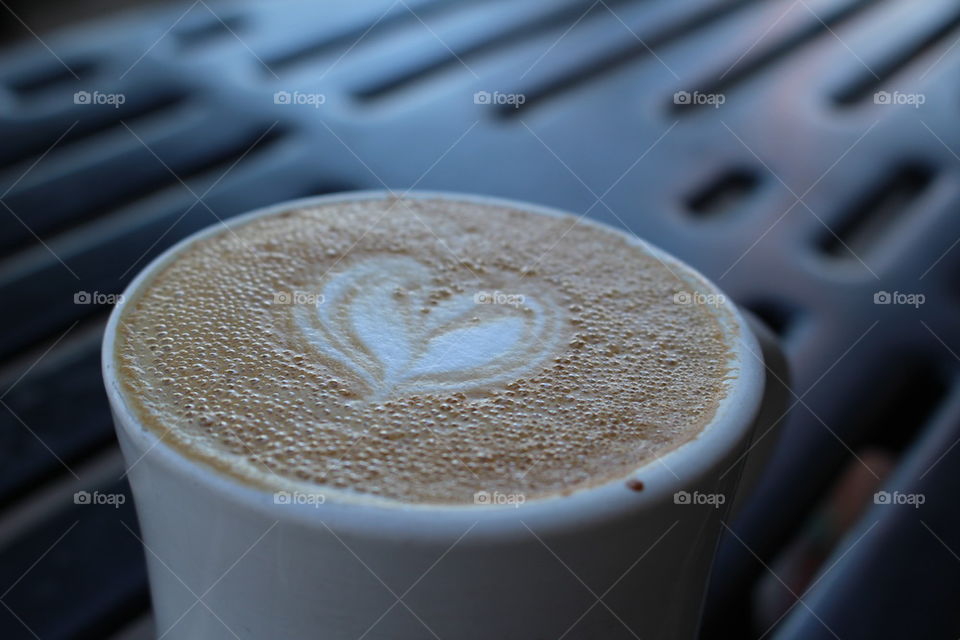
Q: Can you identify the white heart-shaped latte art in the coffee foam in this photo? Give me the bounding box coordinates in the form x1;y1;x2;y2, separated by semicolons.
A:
294;256;563;401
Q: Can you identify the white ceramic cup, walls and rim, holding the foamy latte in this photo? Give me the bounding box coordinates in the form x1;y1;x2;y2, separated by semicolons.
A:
103;192;785;640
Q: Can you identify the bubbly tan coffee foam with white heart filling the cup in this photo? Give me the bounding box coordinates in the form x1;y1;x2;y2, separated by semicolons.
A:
115;199;733;504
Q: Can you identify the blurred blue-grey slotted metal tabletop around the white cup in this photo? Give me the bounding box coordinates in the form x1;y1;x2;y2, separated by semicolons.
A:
0;0;960;638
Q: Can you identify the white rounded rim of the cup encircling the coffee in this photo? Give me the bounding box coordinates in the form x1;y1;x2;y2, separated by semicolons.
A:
101;190;765;539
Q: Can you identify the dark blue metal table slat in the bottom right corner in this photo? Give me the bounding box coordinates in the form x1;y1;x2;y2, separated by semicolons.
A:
774;382;960;640
